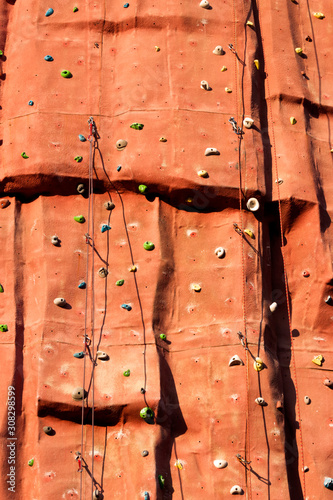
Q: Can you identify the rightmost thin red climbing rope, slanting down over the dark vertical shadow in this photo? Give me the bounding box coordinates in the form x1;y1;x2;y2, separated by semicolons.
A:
257;0;306;498
